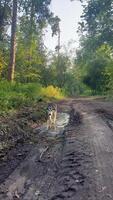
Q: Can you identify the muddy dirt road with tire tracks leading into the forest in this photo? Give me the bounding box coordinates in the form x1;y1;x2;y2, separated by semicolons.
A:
0;99;113;200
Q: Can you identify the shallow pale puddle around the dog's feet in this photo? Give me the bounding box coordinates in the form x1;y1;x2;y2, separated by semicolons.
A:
36;113;70;136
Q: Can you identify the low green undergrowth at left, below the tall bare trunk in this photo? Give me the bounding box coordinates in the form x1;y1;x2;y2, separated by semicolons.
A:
0;81;41;112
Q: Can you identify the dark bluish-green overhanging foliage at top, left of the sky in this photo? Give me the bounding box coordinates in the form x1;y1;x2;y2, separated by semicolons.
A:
20;0;60;35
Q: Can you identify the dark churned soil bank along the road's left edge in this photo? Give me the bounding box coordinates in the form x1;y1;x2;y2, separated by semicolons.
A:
0;103;46;184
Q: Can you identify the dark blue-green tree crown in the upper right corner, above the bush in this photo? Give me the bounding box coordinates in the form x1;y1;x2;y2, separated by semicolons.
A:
80;0;113;45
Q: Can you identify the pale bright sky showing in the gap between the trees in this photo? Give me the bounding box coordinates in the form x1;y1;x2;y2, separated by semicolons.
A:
44;0;82;51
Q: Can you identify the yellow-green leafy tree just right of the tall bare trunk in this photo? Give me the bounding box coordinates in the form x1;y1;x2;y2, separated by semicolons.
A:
15;16;46;82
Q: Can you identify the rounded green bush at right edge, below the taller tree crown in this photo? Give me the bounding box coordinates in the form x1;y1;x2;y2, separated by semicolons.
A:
77;45;113;94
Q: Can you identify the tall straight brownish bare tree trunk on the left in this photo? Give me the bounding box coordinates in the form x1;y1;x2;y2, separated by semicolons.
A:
8;0;17;82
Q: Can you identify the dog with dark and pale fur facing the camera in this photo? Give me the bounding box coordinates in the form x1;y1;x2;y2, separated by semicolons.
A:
47;103;57;129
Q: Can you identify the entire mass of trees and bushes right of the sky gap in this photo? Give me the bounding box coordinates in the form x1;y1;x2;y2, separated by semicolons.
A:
75;0;113;94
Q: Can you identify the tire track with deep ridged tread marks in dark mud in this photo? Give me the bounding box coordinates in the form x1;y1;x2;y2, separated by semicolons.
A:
48;127;92;200
